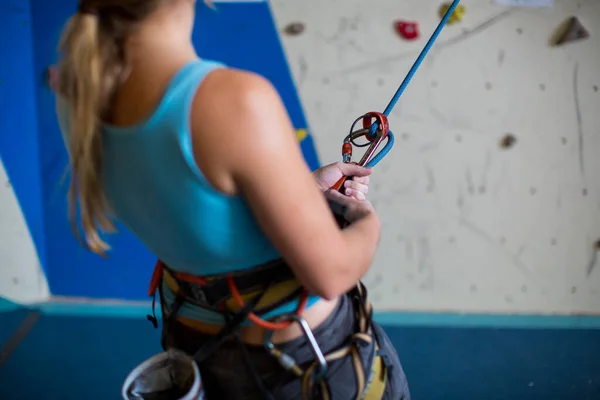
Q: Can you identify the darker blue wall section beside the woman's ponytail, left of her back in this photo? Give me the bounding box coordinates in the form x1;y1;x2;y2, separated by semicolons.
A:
31;0;154;299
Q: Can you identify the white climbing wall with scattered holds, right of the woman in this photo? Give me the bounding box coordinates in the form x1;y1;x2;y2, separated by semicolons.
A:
271;0;600;314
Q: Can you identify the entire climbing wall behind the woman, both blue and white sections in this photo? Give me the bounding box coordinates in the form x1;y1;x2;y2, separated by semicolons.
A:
0;0;600;314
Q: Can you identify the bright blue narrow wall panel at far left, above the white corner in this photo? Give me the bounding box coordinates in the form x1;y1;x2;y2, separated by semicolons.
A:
0;0;45;272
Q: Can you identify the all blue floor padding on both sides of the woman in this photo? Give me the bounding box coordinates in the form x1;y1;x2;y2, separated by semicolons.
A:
0;304;600;400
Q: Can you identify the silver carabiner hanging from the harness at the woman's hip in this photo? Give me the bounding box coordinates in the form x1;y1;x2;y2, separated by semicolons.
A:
264;314;327;383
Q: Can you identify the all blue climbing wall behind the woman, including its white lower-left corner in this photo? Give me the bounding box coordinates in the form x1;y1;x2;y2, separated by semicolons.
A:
0;0;319;302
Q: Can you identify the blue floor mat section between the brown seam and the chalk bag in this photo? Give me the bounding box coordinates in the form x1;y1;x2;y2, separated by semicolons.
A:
0;315;160;400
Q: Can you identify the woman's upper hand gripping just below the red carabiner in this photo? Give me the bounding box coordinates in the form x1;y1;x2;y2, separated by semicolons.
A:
313;162;373;200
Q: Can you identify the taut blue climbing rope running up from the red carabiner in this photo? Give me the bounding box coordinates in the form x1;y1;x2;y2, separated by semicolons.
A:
365;0;460;168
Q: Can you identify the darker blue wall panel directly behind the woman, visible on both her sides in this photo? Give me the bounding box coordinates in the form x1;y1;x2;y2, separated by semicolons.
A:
29;0;318;299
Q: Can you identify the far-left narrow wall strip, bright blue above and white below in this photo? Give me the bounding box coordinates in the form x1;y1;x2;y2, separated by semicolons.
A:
0;0;49;303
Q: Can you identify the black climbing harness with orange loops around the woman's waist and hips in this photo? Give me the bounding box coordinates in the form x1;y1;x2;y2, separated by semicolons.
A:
141;260;385;400
